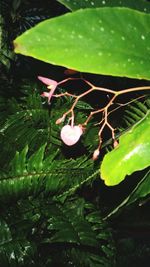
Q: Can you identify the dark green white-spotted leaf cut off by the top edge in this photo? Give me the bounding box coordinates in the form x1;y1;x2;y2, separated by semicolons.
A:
57;0;150;13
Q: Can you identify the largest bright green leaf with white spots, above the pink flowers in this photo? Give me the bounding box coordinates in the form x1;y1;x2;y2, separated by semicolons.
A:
14;8;150;79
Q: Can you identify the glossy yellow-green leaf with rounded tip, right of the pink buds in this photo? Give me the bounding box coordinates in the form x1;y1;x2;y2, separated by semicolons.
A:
100;112;150;186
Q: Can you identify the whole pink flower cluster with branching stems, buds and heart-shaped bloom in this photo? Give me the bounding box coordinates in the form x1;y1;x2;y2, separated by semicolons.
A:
38;76;149;160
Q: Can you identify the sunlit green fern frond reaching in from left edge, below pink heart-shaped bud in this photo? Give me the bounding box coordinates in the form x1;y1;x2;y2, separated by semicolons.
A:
0;144;95;202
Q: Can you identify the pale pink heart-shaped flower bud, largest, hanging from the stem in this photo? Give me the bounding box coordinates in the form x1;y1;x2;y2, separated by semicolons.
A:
60;125;83;146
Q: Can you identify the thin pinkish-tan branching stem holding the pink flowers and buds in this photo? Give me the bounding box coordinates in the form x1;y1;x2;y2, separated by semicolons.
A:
48;78;150;154
